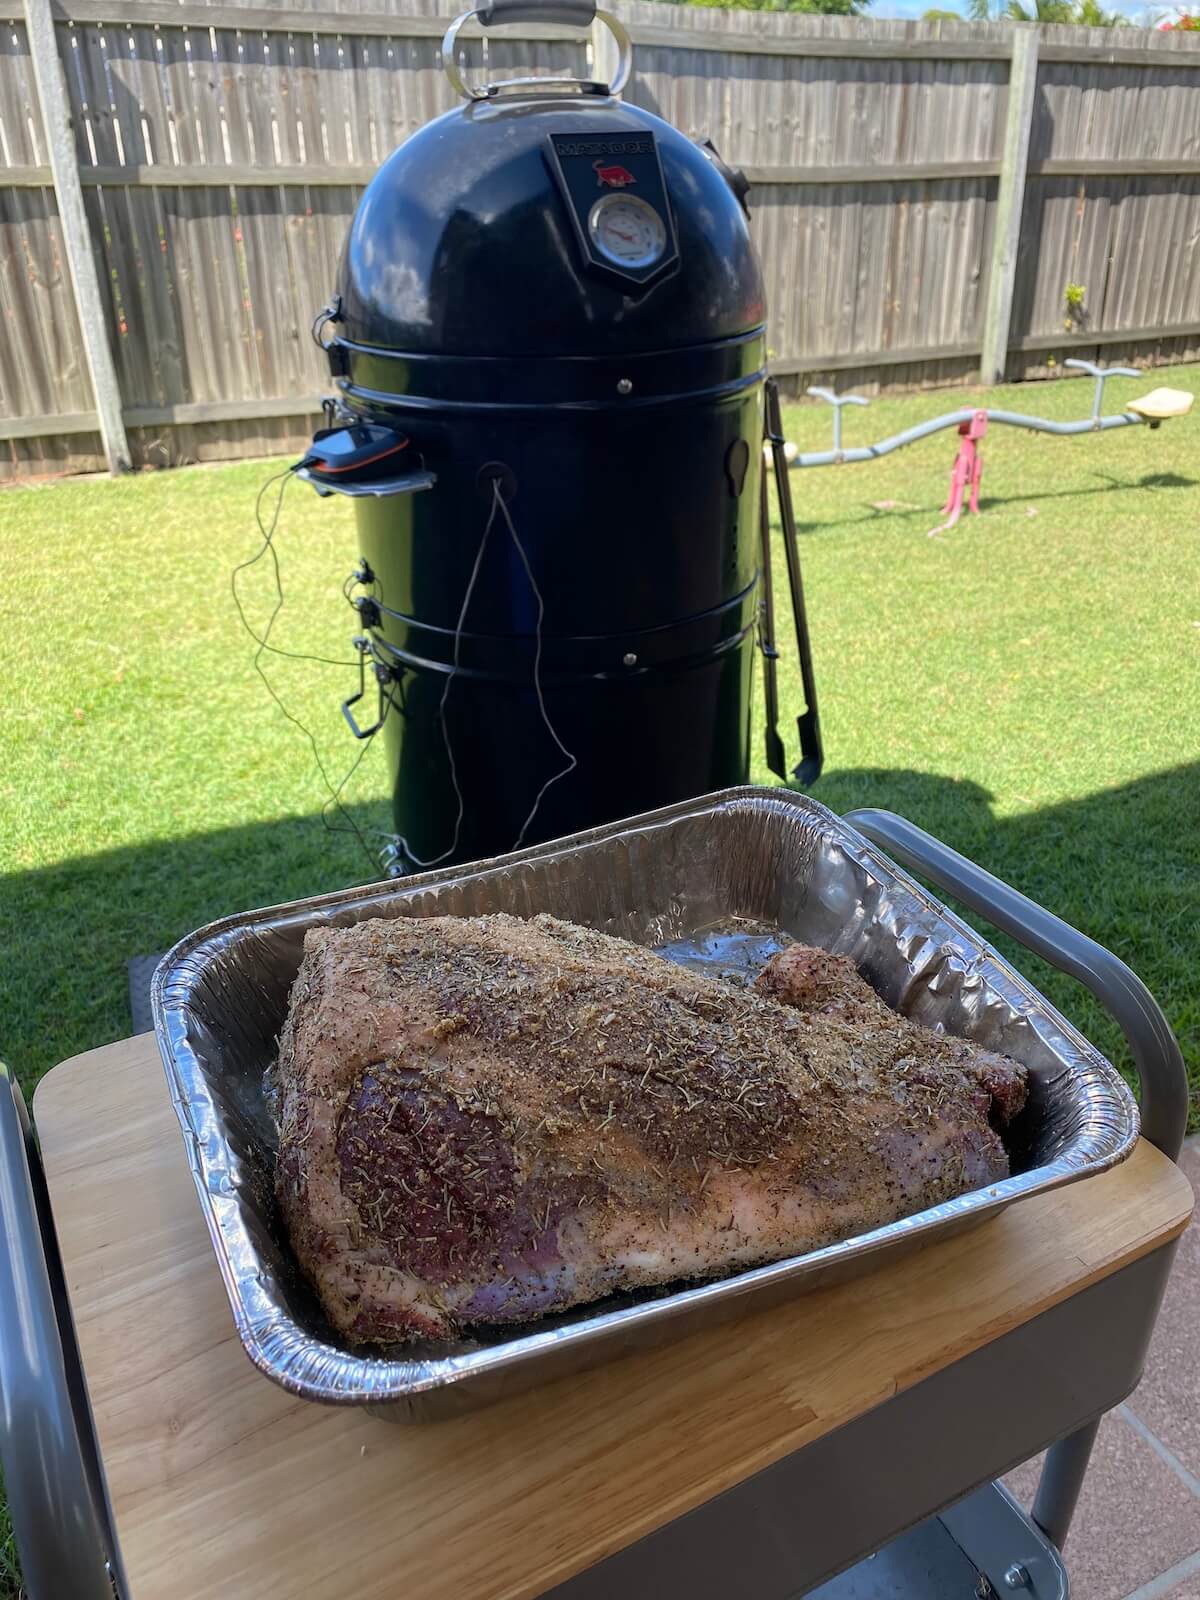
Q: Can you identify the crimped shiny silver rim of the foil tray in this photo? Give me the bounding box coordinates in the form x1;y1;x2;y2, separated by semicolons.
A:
150;786;1139;1406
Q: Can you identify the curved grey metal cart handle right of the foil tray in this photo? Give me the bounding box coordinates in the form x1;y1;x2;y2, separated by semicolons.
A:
845;808;1187;1160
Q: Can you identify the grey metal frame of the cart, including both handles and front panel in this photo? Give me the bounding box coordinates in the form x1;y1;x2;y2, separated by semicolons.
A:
0;810;1187;1600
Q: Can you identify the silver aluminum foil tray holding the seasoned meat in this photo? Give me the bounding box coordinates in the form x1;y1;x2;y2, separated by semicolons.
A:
152;789;1138;1421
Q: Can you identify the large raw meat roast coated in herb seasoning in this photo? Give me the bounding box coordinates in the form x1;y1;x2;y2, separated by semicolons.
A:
274;915;1026;1342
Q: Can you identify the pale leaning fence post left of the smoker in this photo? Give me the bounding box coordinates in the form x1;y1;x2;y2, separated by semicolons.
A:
24;0;130;472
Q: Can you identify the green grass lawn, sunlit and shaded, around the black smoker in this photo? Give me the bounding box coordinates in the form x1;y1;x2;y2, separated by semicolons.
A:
0;366;1200;1597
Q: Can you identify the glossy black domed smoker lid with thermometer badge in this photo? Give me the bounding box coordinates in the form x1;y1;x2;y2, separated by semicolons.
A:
336;96;765;357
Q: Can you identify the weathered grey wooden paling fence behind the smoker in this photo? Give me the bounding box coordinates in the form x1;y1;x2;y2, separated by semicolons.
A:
0;0;1200;477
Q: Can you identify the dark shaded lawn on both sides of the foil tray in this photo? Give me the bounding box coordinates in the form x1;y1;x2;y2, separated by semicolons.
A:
0;763;1200;1120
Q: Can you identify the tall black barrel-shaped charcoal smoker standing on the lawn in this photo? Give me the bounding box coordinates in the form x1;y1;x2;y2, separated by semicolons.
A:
301;0;821;872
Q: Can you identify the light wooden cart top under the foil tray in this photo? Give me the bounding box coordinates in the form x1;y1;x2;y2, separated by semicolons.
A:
34;1034;1192;1600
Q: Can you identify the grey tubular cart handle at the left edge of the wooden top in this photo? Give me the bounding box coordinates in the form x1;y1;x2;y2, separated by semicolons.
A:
0;1061;115;1600
